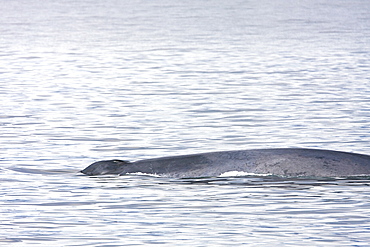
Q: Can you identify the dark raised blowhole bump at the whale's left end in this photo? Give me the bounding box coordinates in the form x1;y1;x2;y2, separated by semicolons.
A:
81;160;131;176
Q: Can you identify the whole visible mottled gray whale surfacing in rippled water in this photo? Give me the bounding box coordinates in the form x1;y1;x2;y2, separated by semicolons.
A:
81;148;370;178
